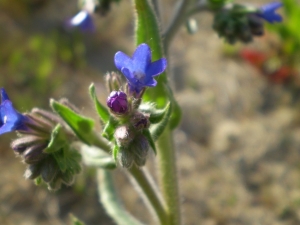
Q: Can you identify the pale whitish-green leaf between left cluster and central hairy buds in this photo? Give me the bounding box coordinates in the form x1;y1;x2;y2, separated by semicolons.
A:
81;145;116;169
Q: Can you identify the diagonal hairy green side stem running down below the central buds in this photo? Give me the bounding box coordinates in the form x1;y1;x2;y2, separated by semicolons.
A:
93;134;167;225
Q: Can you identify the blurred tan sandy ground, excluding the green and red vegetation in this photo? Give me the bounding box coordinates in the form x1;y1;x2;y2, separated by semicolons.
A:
0;0;300;225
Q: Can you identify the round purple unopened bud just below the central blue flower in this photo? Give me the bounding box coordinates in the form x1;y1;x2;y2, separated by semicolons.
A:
106;91;128;114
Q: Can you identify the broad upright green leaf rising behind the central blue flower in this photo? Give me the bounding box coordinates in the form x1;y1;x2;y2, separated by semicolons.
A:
134;0;168;108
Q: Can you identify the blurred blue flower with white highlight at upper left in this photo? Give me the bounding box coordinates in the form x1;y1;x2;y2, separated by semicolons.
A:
66;10;96;32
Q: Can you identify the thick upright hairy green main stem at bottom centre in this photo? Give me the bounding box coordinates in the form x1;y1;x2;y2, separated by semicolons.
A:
158;129;181;225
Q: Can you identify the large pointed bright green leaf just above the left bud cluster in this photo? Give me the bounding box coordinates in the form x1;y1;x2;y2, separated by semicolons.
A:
50;99;94;145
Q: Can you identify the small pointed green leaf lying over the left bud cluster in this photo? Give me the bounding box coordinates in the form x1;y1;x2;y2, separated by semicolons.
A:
43;124;67;153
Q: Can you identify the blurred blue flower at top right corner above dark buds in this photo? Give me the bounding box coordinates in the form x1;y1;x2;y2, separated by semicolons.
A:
257;2;282;23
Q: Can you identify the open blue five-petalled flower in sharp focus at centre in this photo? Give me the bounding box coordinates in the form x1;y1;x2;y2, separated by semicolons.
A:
115;44;167;93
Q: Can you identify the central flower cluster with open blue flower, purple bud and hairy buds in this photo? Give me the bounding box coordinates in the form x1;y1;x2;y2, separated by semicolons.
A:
96;44;169;168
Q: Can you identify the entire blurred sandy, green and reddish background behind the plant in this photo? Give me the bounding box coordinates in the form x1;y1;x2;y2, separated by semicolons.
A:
0;0;300;225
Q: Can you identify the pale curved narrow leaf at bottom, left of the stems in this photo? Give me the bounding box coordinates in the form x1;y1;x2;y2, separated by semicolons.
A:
97;169;142;225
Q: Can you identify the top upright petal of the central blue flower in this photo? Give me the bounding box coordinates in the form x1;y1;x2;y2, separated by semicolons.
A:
132;43;151;73
